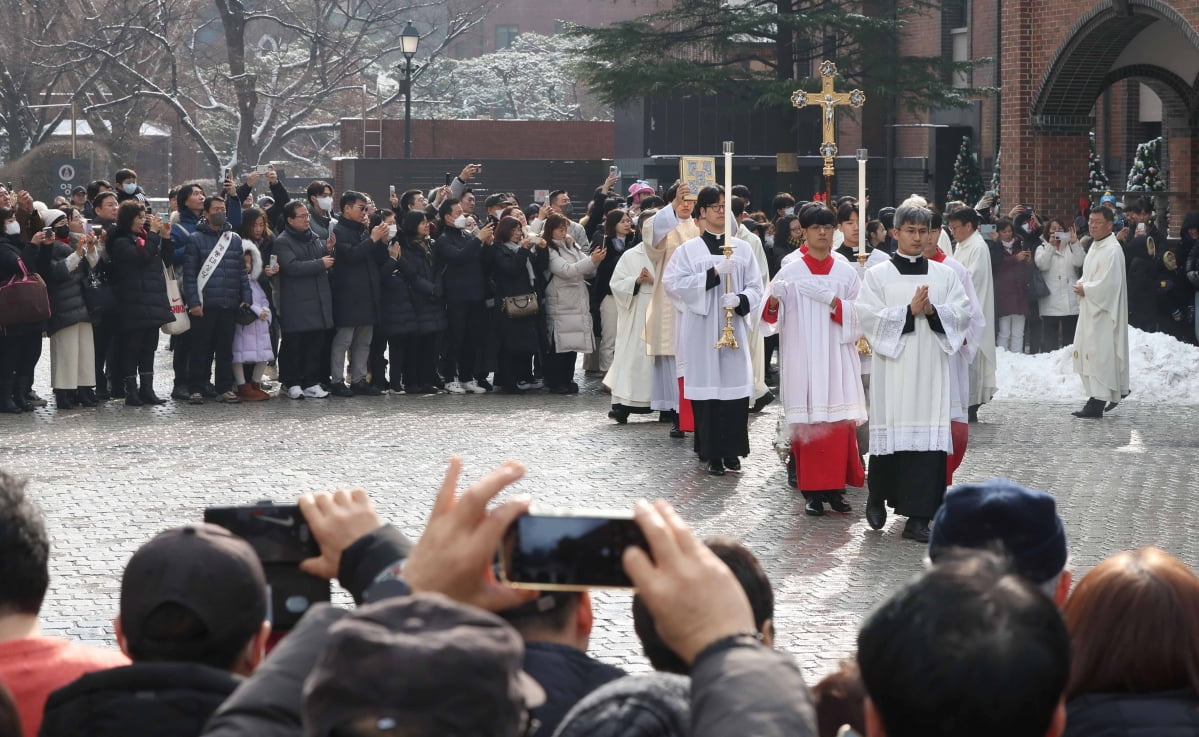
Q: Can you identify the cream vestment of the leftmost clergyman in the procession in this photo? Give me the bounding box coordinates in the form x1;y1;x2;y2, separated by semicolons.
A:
603;243;658;407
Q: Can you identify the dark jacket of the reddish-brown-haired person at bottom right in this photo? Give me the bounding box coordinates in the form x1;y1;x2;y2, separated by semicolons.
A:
1064;689;1199;737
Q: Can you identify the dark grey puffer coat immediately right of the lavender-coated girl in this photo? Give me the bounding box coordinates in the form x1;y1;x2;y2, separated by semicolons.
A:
275;225;333;333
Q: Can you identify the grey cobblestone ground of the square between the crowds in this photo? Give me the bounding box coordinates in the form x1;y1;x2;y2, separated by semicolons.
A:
0;340;1199;682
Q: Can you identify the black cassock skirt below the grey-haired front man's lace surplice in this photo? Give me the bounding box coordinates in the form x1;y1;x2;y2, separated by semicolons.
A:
867;451;948;519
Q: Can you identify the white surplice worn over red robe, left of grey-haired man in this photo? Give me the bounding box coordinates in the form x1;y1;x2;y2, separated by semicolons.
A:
761;256;866;425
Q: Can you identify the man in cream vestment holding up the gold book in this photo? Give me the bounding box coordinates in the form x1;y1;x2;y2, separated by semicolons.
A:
641;182;699;437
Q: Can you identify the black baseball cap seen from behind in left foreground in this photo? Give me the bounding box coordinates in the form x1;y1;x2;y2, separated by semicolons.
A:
120;522;266;662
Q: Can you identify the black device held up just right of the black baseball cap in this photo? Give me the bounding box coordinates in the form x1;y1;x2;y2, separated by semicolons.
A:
204;501;330;632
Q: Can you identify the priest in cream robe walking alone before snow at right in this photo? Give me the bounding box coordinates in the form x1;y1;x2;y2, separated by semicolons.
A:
1073;207;1129;419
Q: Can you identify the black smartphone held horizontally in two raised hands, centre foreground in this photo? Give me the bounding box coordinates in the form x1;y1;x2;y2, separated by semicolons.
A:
500;509;649;591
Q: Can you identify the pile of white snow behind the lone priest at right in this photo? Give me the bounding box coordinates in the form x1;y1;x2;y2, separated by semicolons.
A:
995;327;1199;404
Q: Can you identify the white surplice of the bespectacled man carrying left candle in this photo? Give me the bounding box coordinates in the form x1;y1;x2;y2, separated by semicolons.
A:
662;236;763;400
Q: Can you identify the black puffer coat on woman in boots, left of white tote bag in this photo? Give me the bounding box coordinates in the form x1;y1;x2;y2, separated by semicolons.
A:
108;230;175;331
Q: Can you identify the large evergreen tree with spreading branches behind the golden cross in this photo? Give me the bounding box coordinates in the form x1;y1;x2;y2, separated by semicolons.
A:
565;0;994;151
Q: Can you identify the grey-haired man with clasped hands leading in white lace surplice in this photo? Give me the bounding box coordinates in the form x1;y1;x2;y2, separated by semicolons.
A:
855;204;971;543
